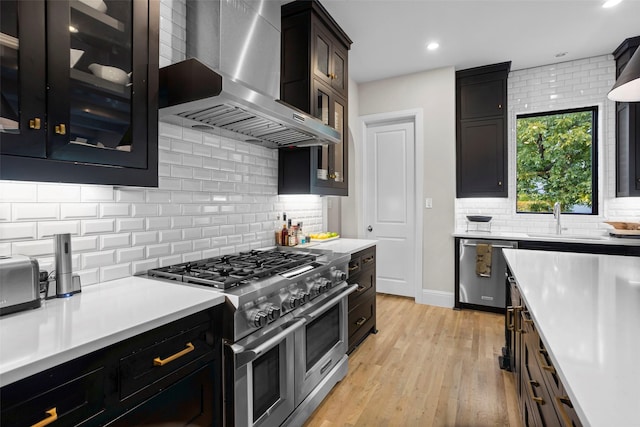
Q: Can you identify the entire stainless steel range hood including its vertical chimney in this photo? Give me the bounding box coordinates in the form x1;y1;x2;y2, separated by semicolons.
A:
159;0;340;148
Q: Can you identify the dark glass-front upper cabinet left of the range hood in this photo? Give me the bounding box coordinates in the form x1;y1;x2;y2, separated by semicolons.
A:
0;0;159;186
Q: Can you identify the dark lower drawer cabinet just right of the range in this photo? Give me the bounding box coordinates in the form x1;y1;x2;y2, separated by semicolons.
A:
347;246;378;353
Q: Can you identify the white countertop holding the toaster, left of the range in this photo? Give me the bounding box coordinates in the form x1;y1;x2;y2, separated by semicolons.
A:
0;277;224;386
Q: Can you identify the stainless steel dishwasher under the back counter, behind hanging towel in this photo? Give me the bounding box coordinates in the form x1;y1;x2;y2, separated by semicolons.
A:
459;239;518;308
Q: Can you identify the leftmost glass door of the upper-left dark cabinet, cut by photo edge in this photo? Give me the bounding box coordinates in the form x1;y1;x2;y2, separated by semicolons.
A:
0;0;46;157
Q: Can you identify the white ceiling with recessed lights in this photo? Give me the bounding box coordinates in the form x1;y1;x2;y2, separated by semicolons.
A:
321;0;640;83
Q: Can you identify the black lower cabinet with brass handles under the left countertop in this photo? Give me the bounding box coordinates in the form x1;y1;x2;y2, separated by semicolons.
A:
0;308;222;426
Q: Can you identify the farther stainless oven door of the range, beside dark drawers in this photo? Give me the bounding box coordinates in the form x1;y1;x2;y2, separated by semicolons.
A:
295;282;358;406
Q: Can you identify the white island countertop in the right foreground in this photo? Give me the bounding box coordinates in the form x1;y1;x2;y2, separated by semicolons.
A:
504;249;640;427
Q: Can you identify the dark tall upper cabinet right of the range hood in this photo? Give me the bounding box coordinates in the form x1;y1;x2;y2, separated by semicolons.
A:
278;0;351;196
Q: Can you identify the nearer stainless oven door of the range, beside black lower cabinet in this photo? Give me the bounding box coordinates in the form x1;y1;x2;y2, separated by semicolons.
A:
224;319;305;427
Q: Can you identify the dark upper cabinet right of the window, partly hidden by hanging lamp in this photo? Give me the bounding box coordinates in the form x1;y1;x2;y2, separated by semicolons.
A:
613;36;640;197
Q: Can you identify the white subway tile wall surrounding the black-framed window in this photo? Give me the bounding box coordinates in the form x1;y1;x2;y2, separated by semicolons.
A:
456;55;640;235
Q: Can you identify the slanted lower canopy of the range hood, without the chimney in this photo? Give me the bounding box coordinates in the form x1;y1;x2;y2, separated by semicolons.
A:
159;58;340;148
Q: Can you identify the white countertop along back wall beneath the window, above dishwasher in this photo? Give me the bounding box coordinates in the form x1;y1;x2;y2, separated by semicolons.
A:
453;231;640;246
